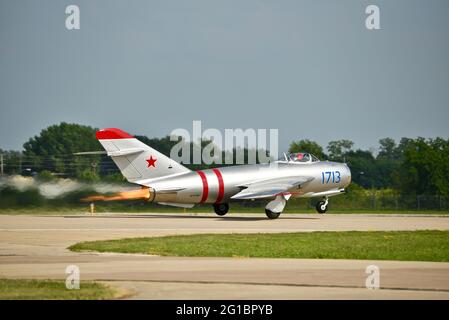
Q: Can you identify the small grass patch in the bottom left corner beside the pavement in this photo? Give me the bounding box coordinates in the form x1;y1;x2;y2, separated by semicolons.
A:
0;279;117;300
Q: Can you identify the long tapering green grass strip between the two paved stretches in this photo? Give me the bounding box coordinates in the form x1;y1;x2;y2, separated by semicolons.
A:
69;231;449;261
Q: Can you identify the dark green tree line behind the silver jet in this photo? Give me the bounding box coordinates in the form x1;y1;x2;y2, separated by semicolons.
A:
0;122;449;196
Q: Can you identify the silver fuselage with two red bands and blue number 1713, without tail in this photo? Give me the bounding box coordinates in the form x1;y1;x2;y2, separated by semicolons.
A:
141;161;351;204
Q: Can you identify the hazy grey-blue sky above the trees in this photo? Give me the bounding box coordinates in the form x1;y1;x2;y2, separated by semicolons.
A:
0;0;449;151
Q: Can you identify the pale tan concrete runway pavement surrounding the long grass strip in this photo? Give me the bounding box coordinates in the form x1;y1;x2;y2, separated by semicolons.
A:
0;213;449;299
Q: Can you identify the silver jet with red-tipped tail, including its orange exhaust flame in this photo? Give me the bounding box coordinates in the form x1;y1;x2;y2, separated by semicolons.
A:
89;128;351;219
